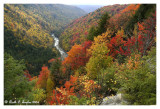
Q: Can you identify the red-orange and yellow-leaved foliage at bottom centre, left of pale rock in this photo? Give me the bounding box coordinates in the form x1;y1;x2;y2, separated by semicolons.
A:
48;75;99;105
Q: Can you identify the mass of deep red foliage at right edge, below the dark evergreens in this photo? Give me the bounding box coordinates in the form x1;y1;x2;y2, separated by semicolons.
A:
108;11;156;57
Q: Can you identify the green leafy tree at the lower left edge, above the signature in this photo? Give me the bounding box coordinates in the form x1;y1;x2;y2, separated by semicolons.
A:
4;53;29;100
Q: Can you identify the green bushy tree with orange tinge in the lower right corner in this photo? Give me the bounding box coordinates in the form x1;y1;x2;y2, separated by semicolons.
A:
116;47;156;105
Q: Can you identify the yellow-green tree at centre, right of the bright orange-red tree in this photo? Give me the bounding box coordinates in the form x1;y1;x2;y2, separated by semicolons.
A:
86;42;112;82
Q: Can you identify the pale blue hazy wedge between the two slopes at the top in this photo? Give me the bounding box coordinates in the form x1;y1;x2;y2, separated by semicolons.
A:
75;5;103;13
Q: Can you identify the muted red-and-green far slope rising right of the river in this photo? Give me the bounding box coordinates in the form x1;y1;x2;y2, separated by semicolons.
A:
60;5;128;51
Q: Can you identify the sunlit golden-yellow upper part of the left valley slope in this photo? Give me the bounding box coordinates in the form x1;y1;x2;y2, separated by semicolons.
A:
4;4;85;47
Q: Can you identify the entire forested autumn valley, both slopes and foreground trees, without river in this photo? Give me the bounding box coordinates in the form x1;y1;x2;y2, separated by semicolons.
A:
4;4;156;105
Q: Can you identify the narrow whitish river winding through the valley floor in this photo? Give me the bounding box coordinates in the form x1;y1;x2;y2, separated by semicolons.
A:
52;34;68;60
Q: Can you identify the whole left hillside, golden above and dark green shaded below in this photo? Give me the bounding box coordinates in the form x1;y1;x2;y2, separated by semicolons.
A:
4;4;85;73
